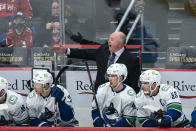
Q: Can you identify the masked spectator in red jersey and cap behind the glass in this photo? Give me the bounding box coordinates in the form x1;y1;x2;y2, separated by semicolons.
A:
6;12;33;48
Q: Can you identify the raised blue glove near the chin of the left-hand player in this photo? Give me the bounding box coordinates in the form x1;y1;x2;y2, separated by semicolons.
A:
50;86;64;102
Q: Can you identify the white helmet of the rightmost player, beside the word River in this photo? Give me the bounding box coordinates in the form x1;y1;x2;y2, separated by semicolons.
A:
140;70;161;87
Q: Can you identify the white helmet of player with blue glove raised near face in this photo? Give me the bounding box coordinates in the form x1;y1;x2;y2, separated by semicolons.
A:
33;71;53;87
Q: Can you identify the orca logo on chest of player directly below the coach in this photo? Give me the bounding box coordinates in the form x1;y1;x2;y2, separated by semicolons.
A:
102;103;119;125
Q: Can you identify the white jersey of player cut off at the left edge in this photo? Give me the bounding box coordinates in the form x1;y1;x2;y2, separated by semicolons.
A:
0;90;28;125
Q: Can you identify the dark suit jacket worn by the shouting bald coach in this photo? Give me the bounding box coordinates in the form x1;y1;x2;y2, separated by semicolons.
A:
68;43;141;93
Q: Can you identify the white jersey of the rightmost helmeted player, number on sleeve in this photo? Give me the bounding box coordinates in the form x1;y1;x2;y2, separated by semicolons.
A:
135;84;187;127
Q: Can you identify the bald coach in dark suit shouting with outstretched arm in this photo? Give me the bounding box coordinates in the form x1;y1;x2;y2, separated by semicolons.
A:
52;32;140;93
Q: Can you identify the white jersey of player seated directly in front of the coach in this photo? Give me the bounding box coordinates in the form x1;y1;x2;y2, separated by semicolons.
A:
92;82;136;126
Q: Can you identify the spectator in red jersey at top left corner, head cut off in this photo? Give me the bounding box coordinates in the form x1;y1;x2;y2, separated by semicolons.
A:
0;0;33;46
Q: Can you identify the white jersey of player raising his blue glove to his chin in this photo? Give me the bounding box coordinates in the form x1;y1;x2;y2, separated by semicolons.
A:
26;85;75;126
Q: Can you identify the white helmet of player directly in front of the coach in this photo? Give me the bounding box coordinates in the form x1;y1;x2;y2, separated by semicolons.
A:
107;63;127;82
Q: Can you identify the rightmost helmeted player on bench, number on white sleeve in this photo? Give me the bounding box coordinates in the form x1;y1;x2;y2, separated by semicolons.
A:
135;70;189;128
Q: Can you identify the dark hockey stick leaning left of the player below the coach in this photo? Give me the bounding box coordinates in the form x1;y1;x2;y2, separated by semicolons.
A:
84;61;105;124
